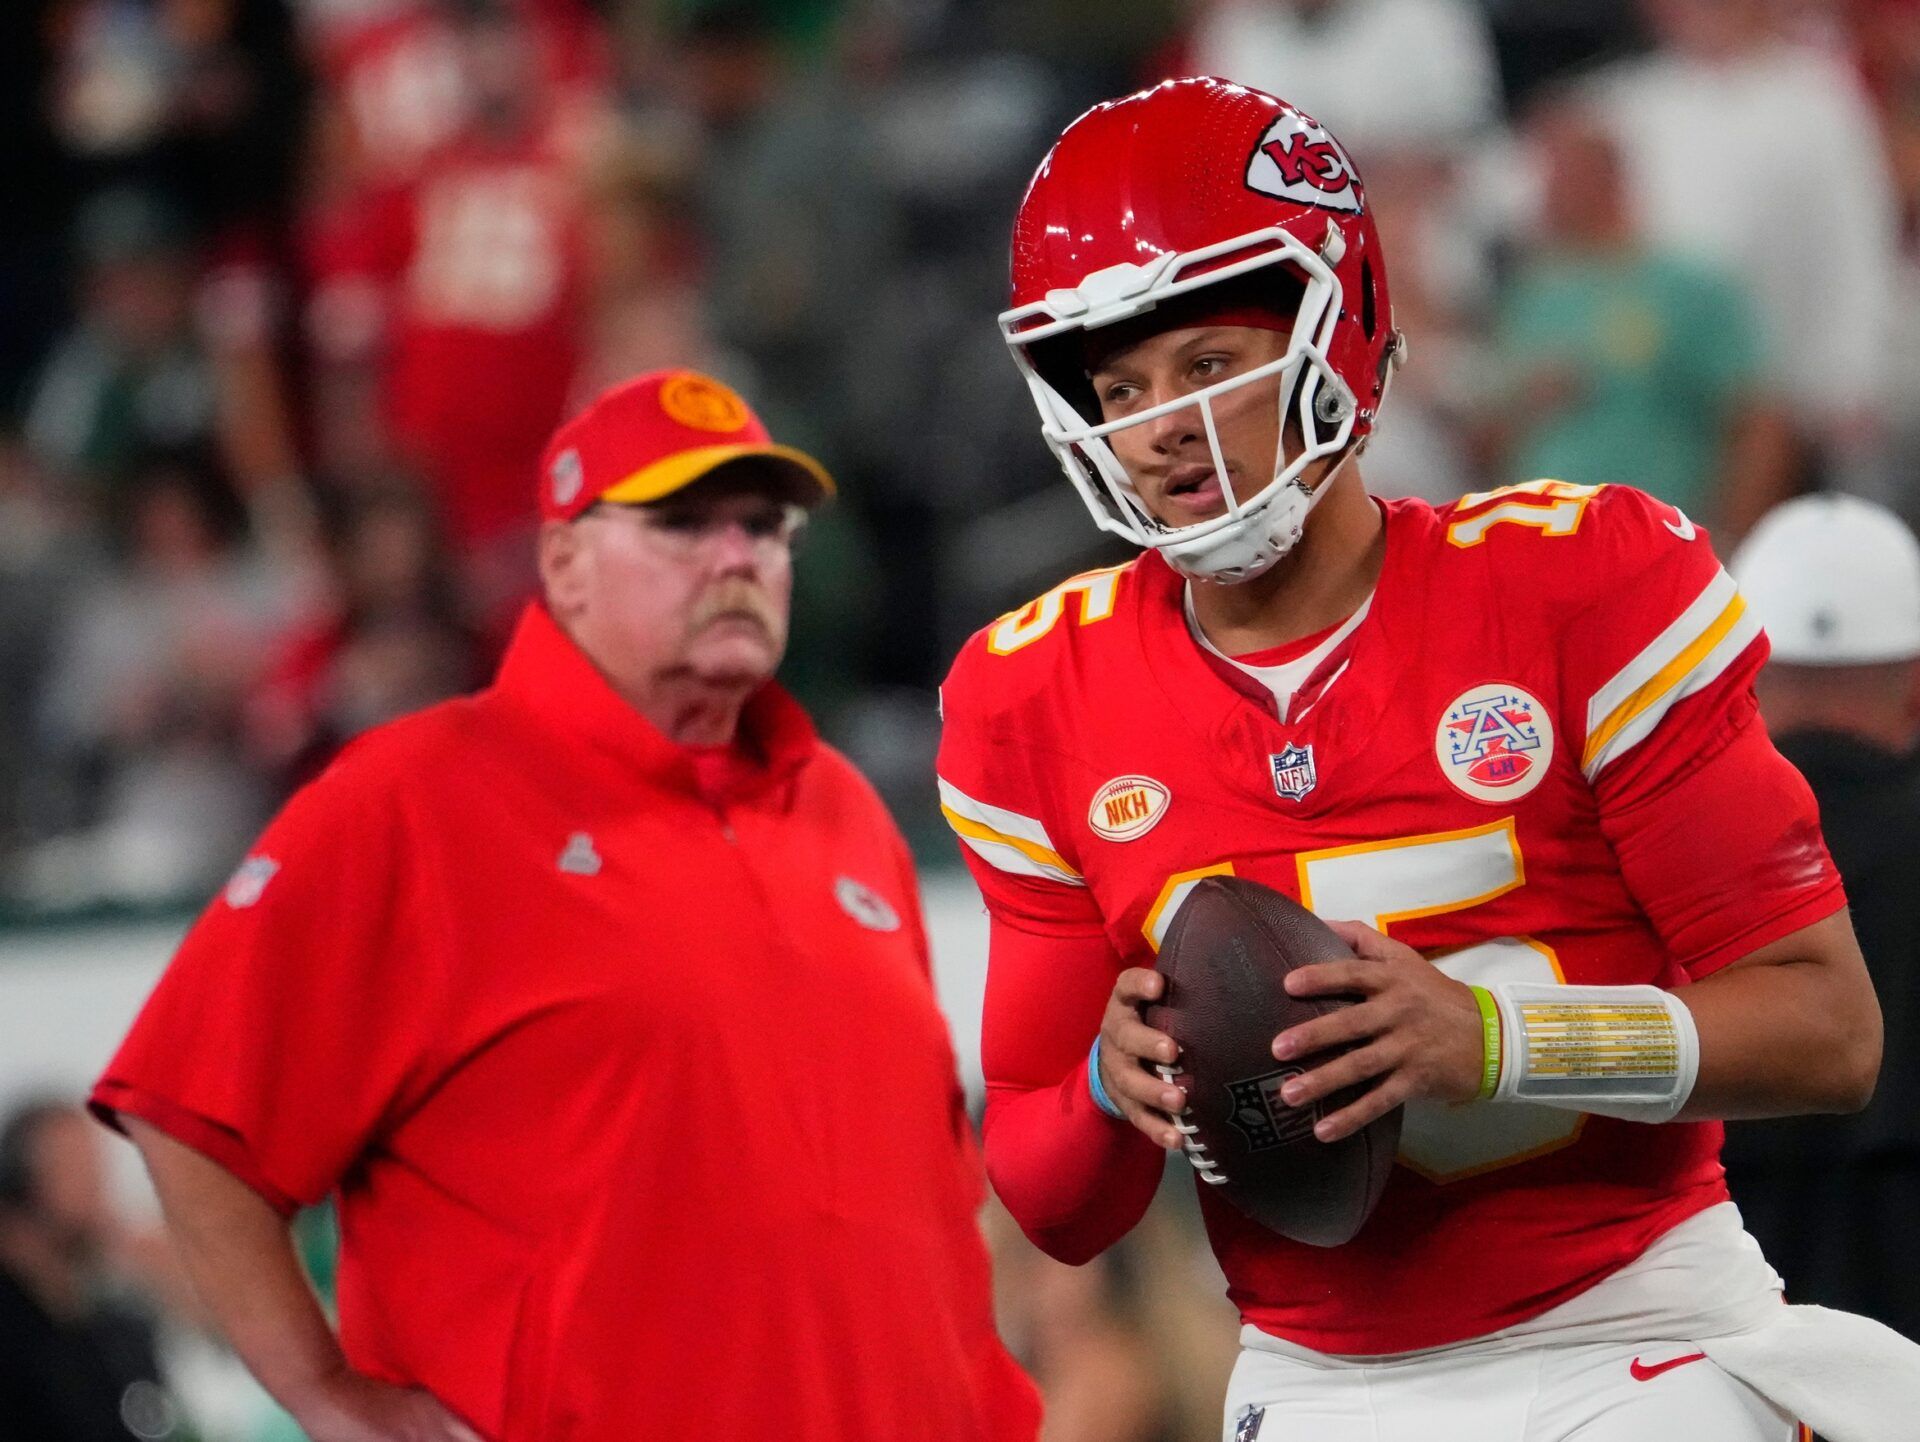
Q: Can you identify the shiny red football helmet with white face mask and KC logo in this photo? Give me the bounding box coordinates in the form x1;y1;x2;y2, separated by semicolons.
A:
1000;77;1404;582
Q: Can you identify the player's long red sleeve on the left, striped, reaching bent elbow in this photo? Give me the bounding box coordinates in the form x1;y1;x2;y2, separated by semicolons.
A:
939;639;1164;1263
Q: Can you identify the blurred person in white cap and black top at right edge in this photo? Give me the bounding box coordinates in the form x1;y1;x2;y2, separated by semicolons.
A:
1724;495;1920;1336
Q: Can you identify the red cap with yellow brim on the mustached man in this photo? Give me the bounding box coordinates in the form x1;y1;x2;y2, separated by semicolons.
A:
540;371;833;520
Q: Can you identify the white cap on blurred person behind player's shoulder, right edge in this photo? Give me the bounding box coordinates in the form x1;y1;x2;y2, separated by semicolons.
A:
1730;495;1920;666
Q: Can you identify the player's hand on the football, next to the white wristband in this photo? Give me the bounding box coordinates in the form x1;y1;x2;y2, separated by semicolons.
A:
1273;922;1484;1142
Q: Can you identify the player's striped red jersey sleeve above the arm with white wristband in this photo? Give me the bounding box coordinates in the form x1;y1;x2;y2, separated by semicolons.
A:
1561;488;1845;979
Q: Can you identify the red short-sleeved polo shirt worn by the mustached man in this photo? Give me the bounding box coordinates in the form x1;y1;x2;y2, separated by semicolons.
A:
94;607;1037;1442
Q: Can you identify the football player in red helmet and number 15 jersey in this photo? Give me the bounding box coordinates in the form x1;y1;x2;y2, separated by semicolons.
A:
939;79;1916;1442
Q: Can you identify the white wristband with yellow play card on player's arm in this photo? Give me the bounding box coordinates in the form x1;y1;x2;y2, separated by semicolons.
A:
1486;981;1699;1121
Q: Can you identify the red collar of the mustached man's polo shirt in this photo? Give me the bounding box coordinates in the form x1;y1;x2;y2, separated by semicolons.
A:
493;601;820;801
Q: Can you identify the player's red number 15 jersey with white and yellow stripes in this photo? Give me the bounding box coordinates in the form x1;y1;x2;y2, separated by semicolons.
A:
939;482;1843;1354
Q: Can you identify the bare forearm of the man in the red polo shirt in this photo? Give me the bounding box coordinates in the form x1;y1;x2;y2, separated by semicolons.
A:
123;1116;348;1419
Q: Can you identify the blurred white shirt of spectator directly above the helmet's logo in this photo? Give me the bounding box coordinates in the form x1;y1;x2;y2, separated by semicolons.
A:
1190;0;1500;159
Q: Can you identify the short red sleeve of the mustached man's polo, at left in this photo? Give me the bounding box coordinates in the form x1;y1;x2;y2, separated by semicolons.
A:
92;758;445;1212
